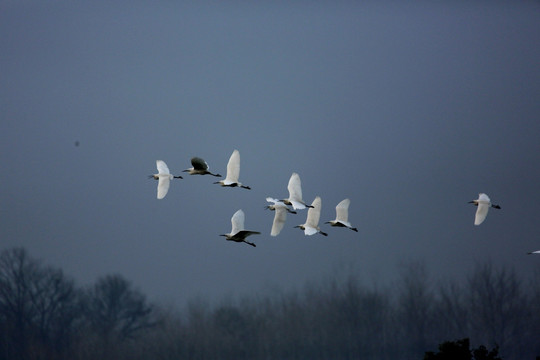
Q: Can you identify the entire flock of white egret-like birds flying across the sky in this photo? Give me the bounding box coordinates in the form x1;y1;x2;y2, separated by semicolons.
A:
150;150;540;254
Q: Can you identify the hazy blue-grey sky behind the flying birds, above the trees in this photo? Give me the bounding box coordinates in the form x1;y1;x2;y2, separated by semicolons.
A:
0;0;540;304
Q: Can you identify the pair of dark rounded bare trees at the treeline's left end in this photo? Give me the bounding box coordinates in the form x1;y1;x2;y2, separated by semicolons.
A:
0;248;154;360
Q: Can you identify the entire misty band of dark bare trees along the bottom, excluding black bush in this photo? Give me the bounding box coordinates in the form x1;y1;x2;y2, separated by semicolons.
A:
0;248;540;360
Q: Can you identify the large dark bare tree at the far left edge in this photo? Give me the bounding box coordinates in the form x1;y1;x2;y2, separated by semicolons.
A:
0;248;78;359
